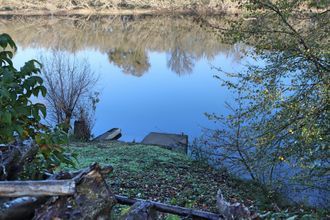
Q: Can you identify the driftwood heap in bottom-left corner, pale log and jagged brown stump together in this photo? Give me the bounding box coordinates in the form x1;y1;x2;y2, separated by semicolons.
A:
0;164;115;220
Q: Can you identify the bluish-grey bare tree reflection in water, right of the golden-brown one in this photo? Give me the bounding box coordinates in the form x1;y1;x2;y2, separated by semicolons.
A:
167;47;195;76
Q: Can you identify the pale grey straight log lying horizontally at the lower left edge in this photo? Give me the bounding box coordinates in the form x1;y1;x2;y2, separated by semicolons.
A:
0;180;76;197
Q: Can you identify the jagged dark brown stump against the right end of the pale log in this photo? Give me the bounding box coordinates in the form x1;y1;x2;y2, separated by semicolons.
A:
34;164;116;220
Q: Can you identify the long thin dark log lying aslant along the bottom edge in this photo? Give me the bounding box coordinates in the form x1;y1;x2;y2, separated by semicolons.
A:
115;195;223;220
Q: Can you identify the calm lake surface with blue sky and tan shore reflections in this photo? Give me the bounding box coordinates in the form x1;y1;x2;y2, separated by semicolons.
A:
0;16;248;141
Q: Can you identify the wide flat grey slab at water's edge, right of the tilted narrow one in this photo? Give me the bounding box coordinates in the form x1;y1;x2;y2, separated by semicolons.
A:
141;132;188;153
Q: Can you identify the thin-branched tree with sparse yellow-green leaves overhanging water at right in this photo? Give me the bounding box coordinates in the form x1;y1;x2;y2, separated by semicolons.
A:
210;0;330;196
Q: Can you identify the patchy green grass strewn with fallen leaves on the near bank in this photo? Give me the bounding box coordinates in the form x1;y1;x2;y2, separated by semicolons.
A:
64;142;270;212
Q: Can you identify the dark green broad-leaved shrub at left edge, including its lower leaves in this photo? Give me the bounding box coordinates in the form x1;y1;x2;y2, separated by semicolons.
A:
0;34;74;176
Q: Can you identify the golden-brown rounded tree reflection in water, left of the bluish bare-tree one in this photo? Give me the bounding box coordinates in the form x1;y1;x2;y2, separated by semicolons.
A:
108;48;150;77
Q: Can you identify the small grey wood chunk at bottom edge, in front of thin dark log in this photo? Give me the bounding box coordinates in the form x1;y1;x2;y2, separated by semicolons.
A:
121;202;157;220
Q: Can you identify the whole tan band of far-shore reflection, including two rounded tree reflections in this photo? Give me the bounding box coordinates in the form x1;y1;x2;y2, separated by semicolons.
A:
0;15;244;76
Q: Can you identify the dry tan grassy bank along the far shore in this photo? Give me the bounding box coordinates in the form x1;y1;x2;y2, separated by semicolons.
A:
0;0;237;15
